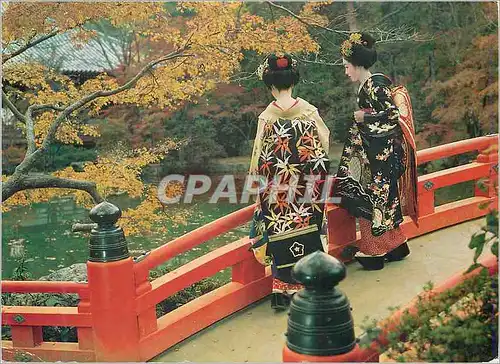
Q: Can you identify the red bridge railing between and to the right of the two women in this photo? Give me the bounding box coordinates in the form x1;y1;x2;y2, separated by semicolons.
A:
327;134;498;257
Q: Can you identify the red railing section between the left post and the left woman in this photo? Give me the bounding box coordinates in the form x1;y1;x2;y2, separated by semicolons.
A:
130;206;271;360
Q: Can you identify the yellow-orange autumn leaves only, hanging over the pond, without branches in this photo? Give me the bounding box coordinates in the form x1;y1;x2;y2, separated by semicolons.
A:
2;2;328;234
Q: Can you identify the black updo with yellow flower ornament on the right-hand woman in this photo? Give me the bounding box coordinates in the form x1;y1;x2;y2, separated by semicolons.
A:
340;33;377;69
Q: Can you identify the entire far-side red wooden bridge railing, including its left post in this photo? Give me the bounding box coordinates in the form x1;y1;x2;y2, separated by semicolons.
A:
2;135;498;362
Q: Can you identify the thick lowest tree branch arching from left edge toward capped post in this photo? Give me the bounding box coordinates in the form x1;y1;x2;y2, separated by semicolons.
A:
2;175;104;203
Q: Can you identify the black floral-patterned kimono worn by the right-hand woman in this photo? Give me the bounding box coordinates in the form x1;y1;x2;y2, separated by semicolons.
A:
334;74;405;236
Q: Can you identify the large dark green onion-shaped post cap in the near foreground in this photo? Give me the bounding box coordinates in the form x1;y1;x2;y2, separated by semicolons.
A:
282;252;378;363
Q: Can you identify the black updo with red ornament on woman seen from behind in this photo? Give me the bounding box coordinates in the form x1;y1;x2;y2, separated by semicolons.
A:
257;54;299;90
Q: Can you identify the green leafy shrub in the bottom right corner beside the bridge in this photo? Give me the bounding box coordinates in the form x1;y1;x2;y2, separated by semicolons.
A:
360;211;498;362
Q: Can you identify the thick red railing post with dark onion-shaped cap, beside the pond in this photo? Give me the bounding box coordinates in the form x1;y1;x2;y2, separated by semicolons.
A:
87;202;141;362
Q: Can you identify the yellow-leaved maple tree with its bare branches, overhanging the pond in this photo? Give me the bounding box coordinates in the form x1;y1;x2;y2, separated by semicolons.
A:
2;2;321;233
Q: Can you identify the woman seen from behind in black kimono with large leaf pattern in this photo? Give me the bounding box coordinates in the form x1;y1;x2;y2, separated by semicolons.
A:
250;56;329;308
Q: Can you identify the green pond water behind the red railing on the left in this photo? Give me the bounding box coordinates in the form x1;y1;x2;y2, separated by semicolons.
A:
2;197;248;279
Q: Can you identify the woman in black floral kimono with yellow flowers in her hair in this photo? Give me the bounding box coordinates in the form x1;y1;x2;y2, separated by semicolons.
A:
334;33;417;270
